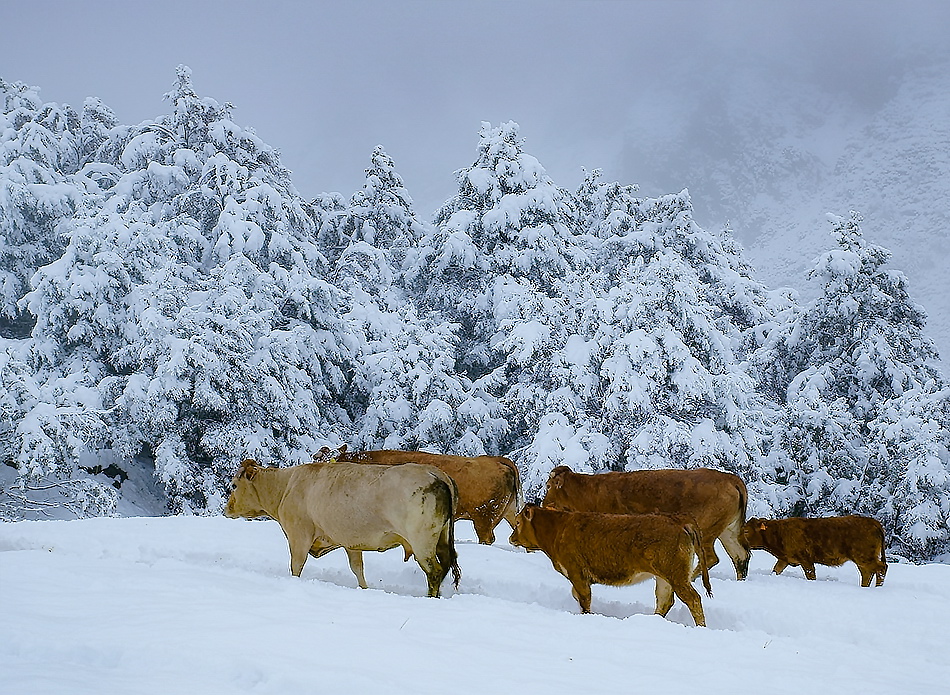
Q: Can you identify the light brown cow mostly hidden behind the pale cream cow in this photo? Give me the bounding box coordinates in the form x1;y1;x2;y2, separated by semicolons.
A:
313;445;521;545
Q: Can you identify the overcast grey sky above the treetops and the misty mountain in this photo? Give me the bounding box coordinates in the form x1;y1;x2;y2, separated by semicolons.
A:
0;0;950;221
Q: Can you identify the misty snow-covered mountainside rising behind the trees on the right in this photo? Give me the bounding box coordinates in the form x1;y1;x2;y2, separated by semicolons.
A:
622;57;950;360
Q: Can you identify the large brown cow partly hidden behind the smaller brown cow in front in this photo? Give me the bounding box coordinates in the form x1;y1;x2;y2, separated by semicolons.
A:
542;466;752;579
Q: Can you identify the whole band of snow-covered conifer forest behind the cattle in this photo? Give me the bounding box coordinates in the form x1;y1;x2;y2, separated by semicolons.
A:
0;67;950;561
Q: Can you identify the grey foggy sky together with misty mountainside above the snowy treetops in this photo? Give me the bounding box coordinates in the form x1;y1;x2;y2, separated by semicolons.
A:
0;0;950;359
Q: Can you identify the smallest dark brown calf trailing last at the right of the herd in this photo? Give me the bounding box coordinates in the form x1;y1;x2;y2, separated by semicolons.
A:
742;514;887;586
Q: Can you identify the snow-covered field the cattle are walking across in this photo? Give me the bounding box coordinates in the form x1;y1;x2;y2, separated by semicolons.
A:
0;517;950;695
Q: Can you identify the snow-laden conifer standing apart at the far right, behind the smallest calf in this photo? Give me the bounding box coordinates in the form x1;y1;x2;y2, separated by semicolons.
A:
755;212;950;560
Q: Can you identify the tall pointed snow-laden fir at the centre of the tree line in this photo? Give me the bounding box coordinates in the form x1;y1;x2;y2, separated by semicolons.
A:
408;122;586;478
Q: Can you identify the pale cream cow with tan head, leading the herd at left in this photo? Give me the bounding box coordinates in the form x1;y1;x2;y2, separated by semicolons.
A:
224;459;460;597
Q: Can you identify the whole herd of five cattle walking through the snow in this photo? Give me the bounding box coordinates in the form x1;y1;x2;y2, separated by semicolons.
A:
224;446;887;626
